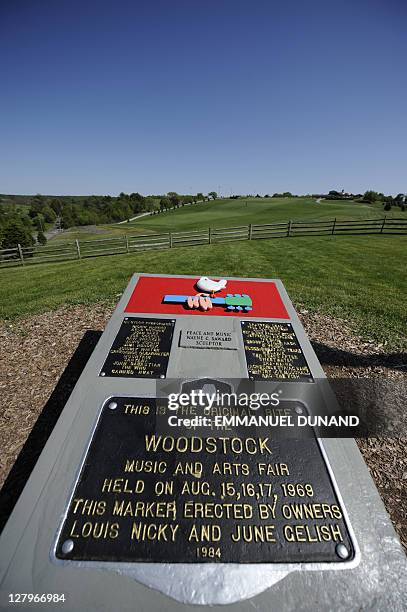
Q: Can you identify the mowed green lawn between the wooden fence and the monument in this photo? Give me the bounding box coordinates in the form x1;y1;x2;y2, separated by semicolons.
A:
0;235;407;349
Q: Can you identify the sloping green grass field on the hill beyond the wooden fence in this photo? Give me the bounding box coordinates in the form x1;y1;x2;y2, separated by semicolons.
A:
48;198;407;242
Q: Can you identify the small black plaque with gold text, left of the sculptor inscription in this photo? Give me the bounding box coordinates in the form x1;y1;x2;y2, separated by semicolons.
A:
100;317;174;378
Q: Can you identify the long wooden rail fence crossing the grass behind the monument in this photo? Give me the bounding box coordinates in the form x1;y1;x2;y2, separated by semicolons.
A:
0;217;407;268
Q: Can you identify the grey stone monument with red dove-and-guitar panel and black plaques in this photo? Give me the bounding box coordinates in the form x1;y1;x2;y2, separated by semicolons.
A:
0;274;407;612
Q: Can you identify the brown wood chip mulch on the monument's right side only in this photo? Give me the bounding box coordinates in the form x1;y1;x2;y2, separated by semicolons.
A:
299;309;407;551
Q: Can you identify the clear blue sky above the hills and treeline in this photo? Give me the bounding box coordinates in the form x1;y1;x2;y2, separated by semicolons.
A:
0;0;407;195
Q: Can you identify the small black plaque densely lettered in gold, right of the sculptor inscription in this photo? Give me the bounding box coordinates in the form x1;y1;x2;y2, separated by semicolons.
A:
241;321;313;382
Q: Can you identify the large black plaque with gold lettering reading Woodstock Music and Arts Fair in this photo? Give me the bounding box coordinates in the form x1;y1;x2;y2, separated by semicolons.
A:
56;397;354;563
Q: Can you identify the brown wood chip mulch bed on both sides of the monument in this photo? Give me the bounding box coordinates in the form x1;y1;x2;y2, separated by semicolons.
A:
0;304;407;550
